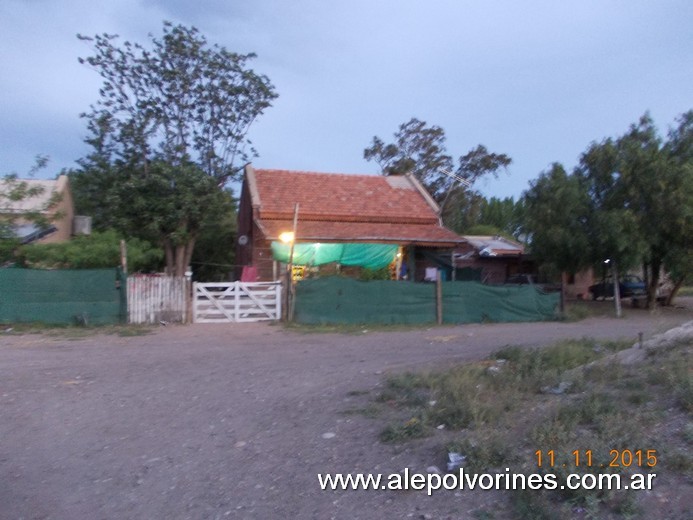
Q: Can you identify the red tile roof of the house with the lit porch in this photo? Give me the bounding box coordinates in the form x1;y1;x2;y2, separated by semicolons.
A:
246;167;464;247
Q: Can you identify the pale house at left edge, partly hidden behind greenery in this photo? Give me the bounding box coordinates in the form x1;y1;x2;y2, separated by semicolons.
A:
0;175;74;244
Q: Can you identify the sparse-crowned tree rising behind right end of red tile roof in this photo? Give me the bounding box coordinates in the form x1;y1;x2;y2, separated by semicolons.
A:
363;118;512;231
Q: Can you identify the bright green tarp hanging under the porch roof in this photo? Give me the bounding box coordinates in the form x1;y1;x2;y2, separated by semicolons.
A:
272;242;399;269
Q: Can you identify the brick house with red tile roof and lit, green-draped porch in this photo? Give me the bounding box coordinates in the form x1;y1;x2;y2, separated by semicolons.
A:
236;165;463;281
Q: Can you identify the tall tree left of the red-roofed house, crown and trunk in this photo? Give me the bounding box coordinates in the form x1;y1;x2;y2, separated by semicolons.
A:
78;22;277;275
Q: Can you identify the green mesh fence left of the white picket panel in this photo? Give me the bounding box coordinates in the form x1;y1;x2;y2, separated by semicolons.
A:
0;269;127;325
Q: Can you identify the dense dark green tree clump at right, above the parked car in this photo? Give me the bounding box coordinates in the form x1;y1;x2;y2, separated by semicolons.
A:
524;111;693;306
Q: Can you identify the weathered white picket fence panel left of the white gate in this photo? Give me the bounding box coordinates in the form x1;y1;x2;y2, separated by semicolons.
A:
127;275;190;323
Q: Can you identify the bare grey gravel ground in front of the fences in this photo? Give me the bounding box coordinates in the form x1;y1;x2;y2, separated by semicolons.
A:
0;302;693;520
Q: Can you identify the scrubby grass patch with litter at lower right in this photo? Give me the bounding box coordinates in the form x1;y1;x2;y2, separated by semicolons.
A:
364;339;693;519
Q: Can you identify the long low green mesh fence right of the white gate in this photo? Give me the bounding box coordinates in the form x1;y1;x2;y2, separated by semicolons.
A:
294;277;559;324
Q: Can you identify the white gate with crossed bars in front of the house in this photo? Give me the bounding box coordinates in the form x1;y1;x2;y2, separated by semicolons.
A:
193;282;282;323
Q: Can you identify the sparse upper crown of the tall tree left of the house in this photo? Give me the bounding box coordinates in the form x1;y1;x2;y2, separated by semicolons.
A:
79;22;277;184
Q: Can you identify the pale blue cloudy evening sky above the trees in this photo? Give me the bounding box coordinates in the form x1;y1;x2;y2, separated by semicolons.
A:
0;0;693;198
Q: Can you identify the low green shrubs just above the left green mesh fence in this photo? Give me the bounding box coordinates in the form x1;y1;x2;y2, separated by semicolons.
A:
18;230;163;272
